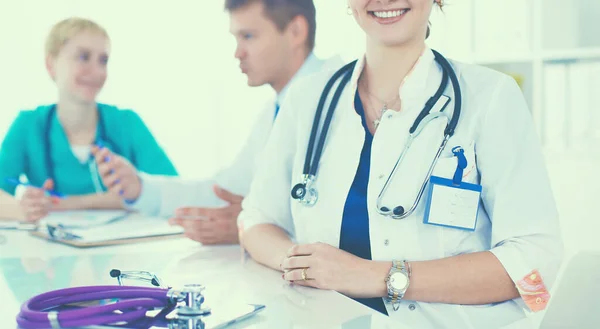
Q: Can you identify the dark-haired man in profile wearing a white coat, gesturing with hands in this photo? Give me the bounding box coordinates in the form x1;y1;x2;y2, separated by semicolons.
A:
95;0;343;244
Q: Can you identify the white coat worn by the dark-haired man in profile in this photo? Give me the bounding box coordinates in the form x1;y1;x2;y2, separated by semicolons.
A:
125;54;342;216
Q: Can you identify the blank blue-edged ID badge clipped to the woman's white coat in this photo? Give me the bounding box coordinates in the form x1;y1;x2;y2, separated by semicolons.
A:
423;146;482;231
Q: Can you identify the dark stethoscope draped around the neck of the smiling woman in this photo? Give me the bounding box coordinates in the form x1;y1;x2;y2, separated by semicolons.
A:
291;50;462;219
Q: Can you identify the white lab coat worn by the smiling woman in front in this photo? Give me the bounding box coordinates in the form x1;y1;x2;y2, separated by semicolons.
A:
238;49;562;329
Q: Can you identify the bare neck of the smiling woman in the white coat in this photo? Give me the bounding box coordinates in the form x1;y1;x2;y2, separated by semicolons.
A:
363;38;425;98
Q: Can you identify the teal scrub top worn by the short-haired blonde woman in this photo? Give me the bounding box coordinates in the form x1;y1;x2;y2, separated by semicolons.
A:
0;104;177;195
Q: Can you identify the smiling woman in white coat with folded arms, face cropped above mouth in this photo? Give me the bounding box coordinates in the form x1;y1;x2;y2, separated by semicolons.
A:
238;0;563;328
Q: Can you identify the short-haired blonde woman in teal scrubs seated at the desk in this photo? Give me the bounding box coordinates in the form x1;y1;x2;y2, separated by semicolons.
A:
0;18;177;221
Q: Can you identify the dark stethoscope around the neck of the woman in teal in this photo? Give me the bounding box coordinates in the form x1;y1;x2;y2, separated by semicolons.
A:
44;106;119;193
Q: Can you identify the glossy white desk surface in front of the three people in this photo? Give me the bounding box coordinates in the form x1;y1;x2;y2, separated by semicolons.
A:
0;231;533;329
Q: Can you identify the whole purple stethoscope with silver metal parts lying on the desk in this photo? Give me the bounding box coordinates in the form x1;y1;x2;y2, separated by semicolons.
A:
17;270;264;329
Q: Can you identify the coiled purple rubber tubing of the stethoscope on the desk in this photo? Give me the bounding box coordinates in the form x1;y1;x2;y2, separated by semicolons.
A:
17;286;170;329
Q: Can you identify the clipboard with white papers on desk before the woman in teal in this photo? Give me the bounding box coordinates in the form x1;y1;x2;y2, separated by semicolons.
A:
30;213;183;248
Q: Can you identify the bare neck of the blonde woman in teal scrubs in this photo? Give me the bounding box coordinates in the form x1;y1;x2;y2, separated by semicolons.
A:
56;97;98;137
